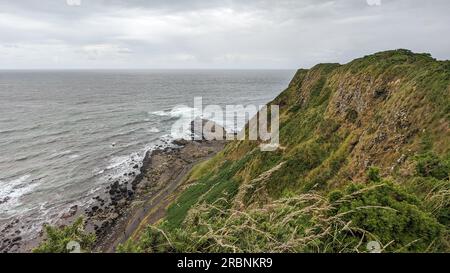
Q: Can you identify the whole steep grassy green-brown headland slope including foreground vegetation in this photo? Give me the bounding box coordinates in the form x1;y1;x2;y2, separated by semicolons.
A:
121;50;450;252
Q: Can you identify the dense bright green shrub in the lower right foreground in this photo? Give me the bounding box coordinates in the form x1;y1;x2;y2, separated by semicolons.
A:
335;182;445;252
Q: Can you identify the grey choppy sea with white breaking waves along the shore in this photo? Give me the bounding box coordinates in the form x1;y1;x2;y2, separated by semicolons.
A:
0;70;295;241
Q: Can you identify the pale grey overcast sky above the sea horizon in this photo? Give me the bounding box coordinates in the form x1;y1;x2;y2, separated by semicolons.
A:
0;0;450;69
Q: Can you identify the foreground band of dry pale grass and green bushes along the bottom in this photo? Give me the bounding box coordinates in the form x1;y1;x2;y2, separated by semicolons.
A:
119;177;447;253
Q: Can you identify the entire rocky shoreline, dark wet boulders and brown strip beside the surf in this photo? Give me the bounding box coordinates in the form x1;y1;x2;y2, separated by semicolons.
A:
0;120;225;252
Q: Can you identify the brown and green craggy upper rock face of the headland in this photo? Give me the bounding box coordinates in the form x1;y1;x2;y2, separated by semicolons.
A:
268;50;450;183
